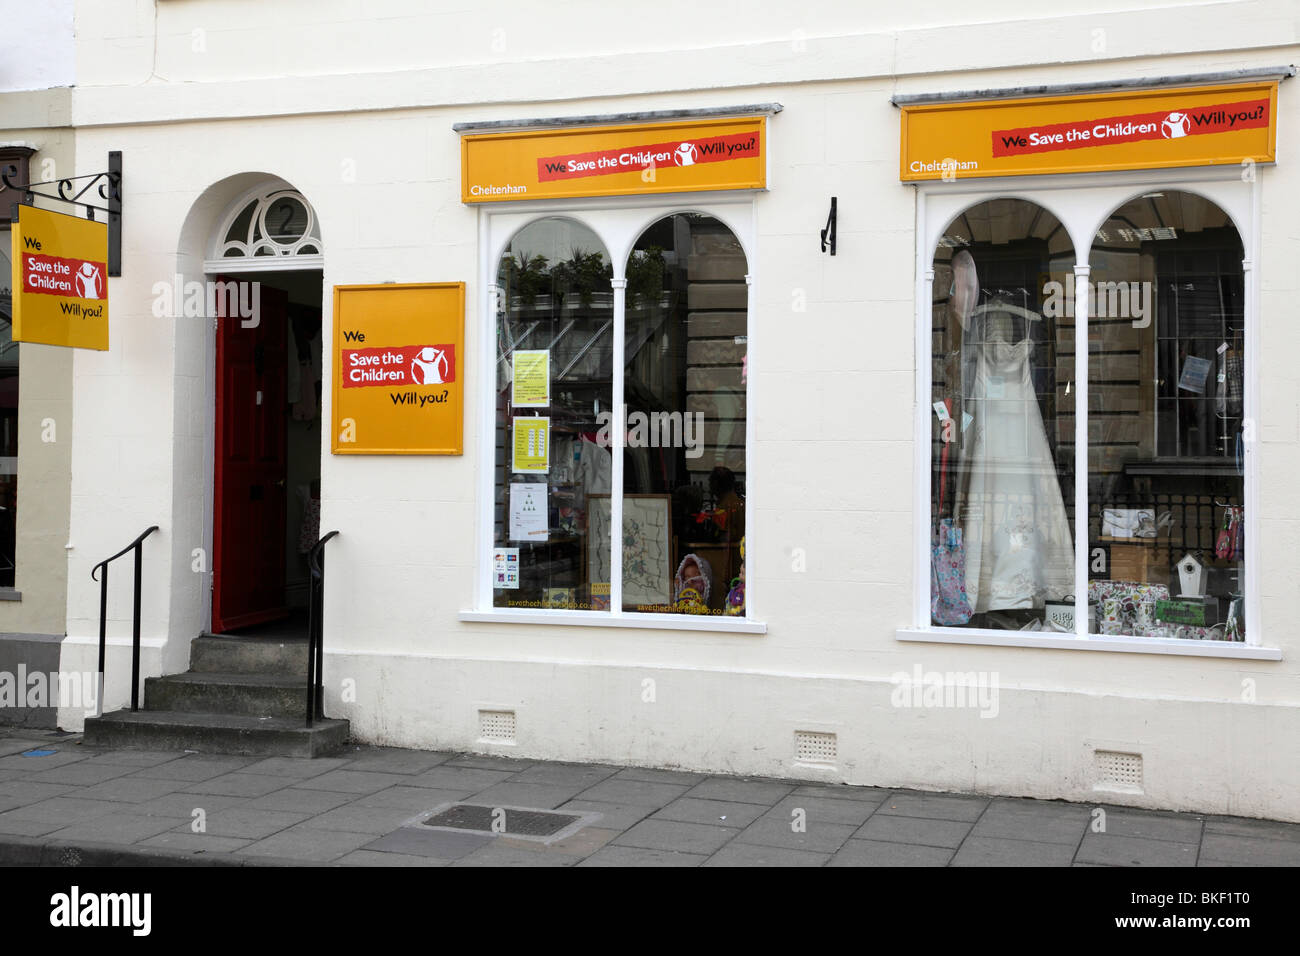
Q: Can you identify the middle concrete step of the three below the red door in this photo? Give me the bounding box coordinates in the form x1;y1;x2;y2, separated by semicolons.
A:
144;671;307;717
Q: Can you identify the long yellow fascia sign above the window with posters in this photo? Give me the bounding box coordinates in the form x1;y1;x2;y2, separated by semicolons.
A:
460;116;767;203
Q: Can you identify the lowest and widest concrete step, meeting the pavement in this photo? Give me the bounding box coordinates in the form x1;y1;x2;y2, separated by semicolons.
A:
85;710;348;757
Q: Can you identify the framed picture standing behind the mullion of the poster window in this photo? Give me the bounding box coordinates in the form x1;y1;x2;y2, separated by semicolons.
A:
586;494;673;610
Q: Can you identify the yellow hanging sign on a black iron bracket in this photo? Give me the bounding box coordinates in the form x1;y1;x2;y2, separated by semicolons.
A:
10;206;108;351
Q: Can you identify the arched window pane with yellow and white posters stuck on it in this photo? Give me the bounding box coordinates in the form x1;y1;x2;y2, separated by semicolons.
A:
493;219;614;611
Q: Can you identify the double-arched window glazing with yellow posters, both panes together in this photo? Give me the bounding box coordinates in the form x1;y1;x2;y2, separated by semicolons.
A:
491;212;749;617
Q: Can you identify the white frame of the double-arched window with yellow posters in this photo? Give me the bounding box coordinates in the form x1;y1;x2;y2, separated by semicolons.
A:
458;191;767;633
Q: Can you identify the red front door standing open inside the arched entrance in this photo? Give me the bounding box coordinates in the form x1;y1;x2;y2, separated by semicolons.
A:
212;280;289;633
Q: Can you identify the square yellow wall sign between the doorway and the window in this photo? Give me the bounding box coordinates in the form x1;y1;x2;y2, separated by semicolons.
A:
330;282;465;455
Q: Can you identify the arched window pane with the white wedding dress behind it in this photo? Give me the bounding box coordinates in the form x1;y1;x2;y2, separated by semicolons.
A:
930;199;1075;630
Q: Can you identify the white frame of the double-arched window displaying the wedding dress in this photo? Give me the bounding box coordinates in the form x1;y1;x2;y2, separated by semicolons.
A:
896;165;1282;661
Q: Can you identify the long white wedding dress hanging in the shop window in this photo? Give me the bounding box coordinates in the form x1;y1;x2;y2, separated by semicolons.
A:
957;302;1074;613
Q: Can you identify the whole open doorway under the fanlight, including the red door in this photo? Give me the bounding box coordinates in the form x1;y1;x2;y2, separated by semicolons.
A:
209;269;322;637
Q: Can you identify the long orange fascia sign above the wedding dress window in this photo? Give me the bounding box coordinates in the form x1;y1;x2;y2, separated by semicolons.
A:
898;81;1278;182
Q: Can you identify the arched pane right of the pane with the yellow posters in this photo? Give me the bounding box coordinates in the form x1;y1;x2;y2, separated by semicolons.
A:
623;213;748;614
